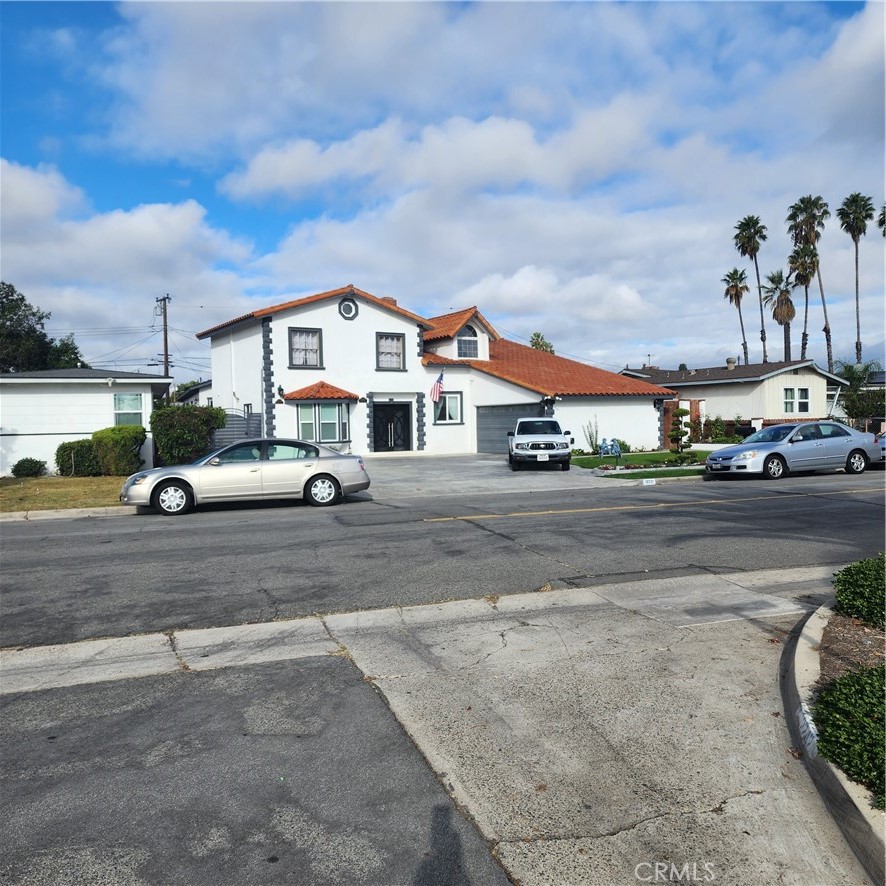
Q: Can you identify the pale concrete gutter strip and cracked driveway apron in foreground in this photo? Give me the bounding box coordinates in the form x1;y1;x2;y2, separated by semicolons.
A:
0;568;867;886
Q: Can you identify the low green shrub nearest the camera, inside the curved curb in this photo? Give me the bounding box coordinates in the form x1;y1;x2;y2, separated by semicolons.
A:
812;665;886;809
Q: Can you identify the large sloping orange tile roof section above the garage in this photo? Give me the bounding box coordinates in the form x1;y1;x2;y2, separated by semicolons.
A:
464;338;675;397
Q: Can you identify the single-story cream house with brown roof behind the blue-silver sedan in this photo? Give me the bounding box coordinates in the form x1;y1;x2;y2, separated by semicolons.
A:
622;358;849;428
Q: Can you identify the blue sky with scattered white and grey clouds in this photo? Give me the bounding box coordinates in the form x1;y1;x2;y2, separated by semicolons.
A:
0;2;886;381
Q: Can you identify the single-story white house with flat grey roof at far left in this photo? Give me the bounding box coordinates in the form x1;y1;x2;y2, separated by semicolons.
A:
0;369;172;476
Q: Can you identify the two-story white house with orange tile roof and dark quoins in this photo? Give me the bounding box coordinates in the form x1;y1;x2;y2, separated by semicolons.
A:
197;286;673;454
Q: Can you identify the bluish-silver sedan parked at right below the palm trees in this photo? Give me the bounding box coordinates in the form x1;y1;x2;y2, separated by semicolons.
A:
705;421;880;480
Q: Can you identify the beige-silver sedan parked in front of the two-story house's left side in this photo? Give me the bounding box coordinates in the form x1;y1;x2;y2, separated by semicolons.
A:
120;438;369;517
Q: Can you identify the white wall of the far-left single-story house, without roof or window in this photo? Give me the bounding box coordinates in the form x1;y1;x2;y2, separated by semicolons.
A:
0;379;153;476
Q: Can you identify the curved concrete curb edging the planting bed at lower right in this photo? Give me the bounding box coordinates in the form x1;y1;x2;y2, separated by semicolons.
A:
783;606;886;886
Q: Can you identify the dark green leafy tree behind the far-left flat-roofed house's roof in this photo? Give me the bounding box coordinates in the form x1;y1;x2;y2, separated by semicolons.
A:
0;282;88;372
